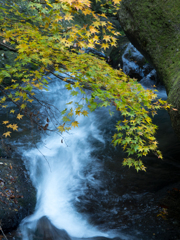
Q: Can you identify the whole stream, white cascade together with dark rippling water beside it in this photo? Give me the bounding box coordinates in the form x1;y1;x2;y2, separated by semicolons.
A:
2;70;180;240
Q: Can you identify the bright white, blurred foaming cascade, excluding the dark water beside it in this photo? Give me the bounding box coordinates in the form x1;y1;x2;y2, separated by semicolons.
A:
20;76;108;239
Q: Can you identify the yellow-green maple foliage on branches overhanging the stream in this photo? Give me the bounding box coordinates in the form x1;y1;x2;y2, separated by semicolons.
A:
0;0;167;171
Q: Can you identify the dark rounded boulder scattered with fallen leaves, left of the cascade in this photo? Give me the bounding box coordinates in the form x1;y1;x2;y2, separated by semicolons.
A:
0;158;36;232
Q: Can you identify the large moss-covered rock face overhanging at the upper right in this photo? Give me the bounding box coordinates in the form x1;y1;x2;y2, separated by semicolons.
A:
118;0;180;137
